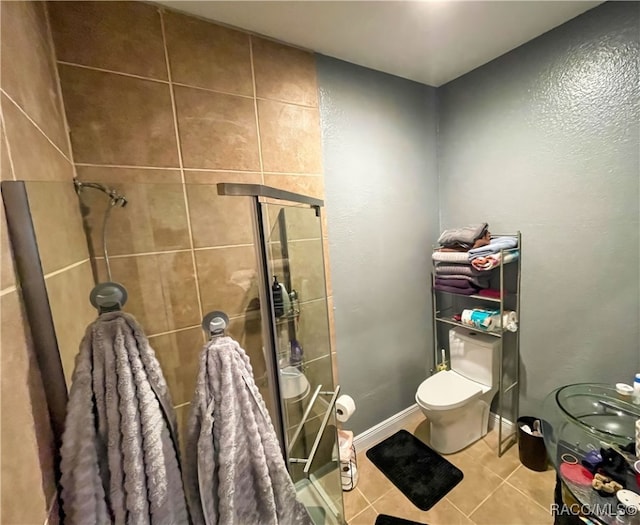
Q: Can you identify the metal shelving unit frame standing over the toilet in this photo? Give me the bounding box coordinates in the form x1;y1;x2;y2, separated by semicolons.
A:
431;231;522;457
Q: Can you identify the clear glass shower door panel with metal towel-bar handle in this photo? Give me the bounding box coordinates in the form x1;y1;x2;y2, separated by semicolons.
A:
260;202;344;525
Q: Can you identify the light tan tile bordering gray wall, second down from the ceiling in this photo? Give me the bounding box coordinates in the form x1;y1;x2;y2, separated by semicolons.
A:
258;100;322;174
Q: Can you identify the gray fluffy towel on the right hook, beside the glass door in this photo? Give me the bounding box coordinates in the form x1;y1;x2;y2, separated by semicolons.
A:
185;337;312;525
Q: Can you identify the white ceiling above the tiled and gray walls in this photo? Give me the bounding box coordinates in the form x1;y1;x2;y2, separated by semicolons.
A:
159;0;602;86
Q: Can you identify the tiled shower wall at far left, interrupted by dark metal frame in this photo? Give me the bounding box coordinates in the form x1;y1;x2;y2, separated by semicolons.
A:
0;2;95;524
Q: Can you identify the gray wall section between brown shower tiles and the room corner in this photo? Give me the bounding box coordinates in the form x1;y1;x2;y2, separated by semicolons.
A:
318;57;438;433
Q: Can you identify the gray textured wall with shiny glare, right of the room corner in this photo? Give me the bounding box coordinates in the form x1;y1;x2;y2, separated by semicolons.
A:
438;2;640;414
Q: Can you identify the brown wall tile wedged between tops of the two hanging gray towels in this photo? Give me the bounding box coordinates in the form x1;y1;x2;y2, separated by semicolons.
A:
149;327;204;405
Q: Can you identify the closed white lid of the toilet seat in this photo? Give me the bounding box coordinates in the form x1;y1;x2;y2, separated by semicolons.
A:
416;370;482;410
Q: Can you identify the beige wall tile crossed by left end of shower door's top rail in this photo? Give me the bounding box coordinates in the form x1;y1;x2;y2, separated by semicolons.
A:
185;171;261;248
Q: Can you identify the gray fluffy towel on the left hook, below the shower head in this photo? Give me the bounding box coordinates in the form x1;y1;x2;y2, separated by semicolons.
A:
61;312;189;525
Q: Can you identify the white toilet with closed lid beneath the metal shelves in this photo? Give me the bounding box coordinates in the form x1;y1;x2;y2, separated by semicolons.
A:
416;328;500;454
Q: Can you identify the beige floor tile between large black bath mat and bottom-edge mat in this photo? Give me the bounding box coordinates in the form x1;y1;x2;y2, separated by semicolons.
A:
373;487;471;525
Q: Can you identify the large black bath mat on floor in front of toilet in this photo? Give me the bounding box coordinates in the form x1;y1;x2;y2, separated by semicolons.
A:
367;430;463;510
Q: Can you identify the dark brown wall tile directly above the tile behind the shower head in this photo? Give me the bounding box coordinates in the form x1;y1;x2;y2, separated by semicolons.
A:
60;65;179;168
